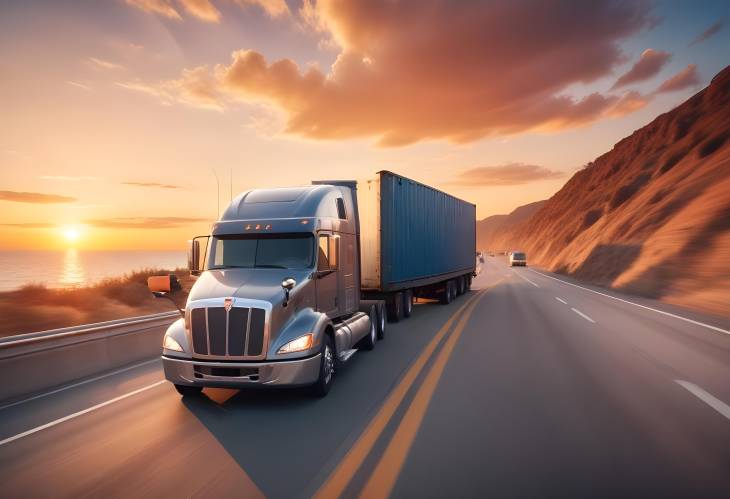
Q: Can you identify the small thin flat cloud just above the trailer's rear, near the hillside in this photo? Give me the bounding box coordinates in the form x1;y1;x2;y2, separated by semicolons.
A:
450;163;565;187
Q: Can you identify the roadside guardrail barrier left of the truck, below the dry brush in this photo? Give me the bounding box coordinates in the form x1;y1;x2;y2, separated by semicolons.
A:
0;312;180;400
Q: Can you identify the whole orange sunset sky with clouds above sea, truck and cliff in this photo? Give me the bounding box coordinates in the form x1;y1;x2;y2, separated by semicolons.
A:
0;0;730;250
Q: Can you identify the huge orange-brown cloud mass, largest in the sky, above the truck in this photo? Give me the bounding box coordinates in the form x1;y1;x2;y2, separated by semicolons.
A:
131;0;651;146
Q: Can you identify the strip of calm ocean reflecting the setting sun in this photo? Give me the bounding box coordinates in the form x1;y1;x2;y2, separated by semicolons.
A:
0;249;187;291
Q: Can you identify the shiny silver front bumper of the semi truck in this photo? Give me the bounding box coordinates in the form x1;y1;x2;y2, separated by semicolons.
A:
162;354;321;388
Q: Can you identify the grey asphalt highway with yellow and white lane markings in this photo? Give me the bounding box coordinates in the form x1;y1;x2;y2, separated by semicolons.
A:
0;258;730;498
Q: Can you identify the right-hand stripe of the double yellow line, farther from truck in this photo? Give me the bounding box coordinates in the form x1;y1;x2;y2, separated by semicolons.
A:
360;288;486;499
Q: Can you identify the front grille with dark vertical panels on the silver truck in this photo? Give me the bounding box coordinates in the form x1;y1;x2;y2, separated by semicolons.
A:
190;307;266;357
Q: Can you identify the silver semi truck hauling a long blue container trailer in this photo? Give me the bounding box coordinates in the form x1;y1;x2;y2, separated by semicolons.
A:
148;171;476;396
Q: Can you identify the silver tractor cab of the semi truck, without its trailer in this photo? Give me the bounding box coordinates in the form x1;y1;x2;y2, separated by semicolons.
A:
162;182;385;396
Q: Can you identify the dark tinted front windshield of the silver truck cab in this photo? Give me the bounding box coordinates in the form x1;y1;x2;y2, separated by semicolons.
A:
207;234;314;270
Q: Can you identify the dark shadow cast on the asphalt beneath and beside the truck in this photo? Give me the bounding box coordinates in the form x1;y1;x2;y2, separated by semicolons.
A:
182;296;468;497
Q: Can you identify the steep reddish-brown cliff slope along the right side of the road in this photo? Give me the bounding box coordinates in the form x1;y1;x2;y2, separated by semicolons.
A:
488;67;730;315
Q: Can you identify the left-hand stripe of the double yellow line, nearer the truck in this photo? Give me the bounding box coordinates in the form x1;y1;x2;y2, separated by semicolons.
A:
314;290;484;499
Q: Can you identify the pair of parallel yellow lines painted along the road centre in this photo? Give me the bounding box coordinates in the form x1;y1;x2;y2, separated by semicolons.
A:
314;289;486;499
